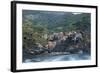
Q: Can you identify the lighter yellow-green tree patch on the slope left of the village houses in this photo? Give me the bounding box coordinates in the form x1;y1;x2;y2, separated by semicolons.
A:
22;21;47;49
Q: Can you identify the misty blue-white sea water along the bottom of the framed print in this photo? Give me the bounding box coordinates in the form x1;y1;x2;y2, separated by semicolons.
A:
24;53;91;63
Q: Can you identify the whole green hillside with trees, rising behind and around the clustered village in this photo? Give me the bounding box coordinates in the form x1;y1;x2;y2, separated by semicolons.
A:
22;10;91;52
